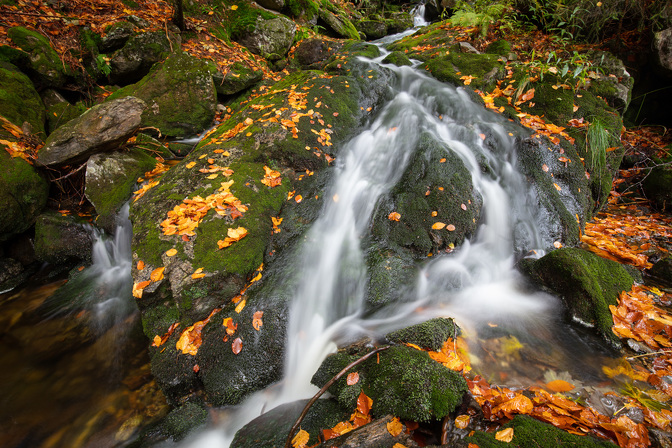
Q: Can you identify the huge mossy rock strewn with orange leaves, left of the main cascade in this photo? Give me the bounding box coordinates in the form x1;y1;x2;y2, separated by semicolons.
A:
131;47;387;405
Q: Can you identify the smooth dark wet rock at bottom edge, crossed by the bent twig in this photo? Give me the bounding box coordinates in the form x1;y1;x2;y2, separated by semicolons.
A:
231;399;352;448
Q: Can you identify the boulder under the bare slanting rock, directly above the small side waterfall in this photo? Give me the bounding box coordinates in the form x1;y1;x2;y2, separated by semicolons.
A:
84;149;156;235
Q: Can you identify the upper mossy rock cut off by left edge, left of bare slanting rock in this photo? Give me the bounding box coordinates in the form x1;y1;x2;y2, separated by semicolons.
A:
0;62;46;139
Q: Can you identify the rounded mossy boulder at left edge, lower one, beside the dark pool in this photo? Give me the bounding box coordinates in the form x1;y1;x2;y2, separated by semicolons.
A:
0;150;49;241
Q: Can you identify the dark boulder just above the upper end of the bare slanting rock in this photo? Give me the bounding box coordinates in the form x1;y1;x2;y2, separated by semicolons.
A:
109;31;180;85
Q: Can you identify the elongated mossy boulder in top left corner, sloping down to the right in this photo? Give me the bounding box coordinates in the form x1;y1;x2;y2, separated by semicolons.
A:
7;26;74;88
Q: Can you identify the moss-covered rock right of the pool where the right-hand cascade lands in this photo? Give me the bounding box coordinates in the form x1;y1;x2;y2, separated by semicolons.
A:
521;248;634;343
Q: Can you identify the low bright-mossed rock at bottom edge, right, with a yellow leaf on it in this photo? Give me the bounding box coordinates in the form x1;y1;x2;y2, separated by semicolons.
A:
459;415;616;448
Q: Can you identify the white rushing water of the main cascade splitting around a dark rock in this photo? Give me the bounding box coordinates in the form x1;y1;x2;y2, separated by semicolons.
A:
175;14;568;448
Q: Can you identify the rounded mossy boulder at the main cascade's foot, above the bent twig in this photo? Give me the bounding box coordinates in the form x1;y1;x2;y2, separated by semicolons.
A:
311;345;467;422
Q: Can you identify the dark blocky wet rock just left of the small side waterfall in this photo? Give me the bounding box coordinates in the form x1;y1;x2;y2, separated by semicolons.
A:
35;212;93;264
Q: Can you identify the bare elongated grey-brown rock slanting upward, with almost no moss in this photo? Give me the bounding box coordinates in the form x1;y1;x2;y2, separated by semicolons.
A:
37;97;146;166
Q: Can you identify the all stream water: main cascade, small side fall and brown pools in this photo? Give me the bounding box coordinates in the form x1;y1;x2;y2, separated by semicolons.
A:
0;9;624;448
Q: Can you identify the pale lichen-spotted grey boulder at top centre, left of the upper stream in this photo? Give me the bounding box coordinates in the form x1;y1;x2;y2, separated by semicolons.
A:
237;16;296;61
